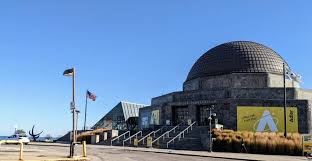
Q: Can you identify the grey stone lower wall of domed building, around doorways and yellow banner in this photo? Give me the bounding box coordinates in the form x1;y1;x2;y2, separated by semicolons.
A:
144;88;312;133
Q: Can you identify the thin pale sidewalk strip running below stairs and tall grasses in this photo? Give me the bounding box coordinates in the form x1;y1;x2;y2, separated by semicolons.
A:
87;145;308;161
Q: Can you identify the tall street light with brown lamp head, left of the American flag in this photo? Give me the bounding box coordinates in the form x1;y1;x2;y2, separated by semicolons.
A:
63;68;76;157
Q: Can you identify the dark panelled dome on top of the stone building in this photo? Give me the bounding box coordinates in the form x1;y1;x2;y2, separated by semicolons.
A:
186;41;289;81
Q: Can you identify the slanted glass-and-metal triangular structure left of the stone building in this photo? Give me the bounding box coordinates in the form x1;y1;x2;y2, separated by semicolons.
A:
92;101;148;130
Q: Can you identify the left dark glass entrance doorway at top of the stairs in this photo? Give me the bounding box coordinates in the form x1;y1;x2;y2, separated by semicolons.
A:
172;106;189;125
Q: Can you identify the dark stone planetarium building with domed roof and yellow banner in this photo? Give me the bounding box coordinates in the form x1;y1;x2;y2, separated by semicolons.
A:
139;41;312;133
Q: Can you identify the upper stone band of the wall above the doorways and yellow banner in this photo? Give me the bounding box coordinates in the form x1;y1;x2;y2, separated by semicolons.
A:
152;88;298;106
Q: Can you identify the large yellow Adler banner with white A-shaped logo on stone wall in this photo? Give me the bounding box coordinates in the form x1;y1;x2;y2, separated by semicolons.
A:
237;106;298;132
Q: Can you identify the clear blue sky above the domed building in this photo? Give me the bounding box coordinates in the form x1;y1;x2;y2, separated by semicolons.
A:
0;0;312;136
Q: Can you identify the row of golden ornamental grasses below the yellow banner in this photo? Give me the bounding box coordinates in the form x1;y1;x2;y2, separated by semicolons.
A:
213;130;302;155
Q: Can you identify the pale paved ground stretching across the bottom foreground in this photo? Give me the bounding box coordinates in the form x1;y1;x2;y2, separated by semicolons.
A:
0;143;307;161
